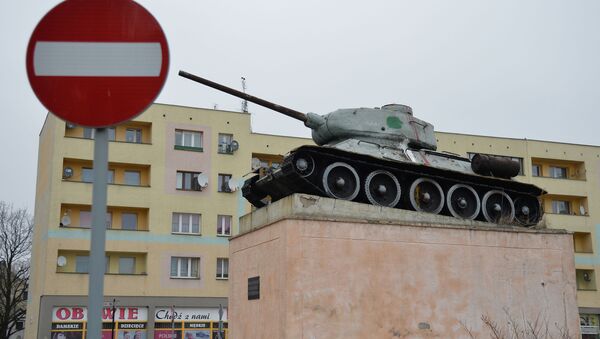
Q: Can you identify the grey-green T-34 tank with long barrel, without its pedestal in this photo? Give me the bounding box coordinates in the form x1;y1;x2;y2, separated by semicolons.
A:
179;71;545;226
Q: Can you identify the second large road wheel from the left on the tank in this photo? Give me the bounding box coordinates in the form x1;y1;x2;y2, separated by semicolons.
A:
365;170;400;207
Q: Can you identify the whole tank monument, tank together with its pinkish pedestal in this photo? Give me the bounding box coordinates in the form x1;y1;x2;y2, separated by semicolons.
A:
179;71;579;339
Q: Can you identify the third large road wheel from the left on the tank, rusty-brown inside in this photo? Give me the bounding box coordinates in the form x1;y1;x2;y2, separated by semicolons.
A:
410;178;444;214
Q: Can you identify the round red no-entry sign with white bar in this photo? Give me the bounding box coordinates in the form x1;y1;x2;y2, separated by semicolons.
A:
26;0;169;127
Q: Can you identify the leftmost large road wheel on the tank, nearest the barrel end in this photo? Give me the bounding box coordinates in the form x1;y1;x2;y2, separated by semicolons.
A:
323;162;360;200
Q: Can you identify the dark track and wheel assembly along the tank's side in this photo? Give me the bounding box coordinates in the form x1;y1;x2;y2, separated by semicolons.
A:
242;146;544;226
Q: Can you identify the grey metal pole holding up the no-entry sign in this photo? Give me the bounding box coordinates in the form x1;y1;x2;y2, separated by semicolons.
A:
87;128;108;339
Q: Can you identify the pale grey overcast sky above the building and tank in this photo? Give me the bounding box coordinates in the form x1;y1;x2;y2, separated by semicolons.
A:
0;0;600;210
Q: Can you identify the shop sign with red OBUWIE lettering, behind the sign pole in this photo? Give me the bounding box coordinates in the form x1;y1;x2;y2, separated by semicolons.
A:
50;306;148;339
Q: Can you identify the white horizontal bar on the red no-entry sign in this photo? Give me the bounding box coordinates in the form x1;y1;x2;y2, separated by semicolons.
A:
33;41;162;77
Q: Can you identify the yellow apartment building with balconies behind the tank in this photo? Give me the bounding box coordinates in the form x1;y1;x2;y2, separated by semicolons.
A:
25;104;600;338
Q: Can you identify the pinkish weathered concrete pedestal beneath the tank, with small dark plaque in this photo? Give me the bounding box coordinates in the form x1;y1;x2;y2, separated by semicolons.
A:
229;194;579;339
